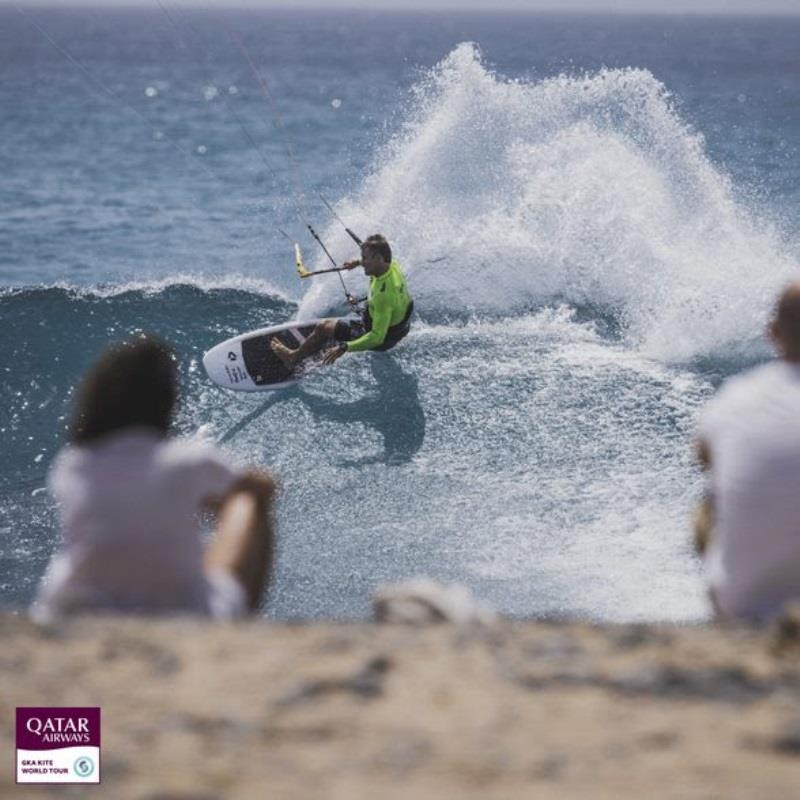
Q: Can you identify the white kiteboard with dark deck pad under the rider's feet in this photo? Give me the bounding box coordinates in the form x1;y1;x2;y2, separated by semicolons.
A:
208;319;332;392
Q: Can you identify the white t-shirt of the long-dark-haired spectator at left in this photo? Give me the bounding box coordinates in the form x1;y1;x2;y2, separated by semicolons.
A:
34;428;243;617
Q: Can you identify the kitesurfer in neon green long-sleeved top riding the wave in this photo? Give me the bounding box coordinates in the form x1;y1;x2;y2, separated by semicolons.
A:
270;233;414;369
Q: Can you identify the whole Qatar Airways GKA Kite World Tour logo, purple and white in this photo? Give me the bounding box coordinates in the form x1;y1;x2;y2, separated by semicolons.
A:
17;707;100;783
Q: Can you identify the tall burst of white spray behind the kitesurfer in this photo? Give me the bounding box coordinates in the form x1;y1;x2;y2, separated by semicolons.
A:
300;44;798;361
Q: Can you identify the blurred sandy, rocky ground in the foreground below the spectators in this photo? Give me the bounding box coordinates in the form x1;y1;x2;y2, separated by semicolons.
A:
0;614;800;800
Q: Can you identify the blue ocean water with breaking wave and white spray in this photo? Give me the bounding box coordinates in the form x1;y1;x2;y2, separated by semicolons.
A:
0;0;800;622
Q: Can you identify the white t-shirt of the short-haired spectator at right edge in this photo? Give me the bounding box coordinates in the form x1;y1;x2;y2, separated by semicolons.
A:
699;361;800;619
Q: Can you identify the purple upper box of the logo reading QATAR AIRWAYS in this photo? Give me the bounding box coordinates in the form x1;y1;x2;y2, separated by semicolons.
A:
17;707;100;750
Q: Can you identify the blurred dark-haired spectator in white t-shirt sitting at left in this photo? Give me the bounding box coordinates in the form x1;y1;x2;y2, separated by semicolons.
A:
33;336;275;619
